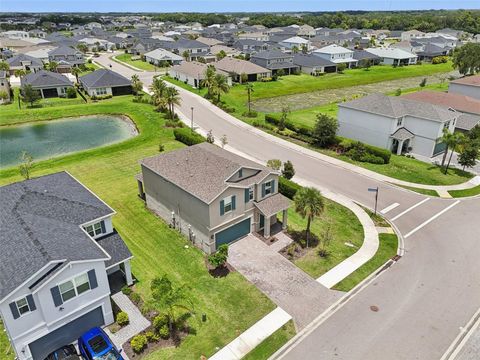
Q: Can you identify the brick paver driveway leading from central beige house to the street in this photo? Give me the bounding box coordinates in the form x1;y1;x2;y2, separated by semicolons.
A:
228;235;341;330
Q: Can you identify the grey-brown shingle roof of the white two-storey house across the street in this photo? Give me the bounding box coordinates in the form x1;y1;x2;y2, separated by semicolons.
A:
338;94;460;123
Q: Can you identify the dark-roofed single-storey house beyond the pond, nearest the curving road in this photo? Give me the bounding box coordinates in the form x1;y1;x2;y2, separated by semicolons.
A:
78;69;132;96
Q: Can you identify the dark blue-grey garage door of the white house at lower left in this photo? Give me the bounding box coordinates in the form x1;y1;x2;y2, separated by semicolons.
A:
29;306;105;360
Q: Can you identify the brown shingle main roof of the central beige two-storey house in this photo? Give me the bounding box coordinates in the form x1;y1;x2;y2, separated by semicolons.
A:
141;143;273;204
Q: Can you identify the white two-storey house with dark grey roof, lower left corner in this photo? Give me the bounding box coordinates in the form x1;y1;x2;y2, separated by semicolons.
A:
0;172;132;360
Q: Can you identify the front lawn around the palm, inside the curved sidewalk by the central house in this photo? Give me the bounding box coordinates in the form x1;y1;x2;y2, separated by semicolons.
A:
288;199;363;278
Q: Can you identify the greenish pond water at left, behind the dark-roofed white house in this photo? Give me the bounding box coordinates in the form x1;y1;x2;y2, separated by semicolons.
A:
0;115;136;168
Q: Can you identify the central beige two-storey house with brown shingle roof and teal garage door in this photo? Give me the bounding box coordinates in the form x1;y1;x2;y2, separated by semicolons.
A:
137;143;290;253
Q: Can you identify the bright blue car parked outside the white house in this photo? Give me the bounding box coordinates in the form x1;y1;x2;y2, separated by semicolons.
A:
78;327;124;360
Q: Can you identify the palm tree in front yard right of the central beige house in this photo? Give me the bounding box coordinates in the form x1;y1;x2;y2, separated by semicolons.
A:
293;187;325;248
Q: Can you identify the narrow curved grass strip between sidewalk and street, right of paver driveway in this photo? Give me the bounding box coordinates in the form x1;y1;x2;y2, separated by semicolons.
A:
333;234;398;291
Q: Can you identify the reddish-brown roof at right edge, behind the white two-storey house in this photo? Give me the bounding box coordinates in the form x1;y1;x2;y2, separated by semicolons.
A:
402;90;480;115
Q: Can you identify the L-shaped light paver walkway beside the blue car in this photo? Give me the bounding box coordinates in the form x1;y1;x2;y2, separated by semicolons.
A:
105;292;150;348
